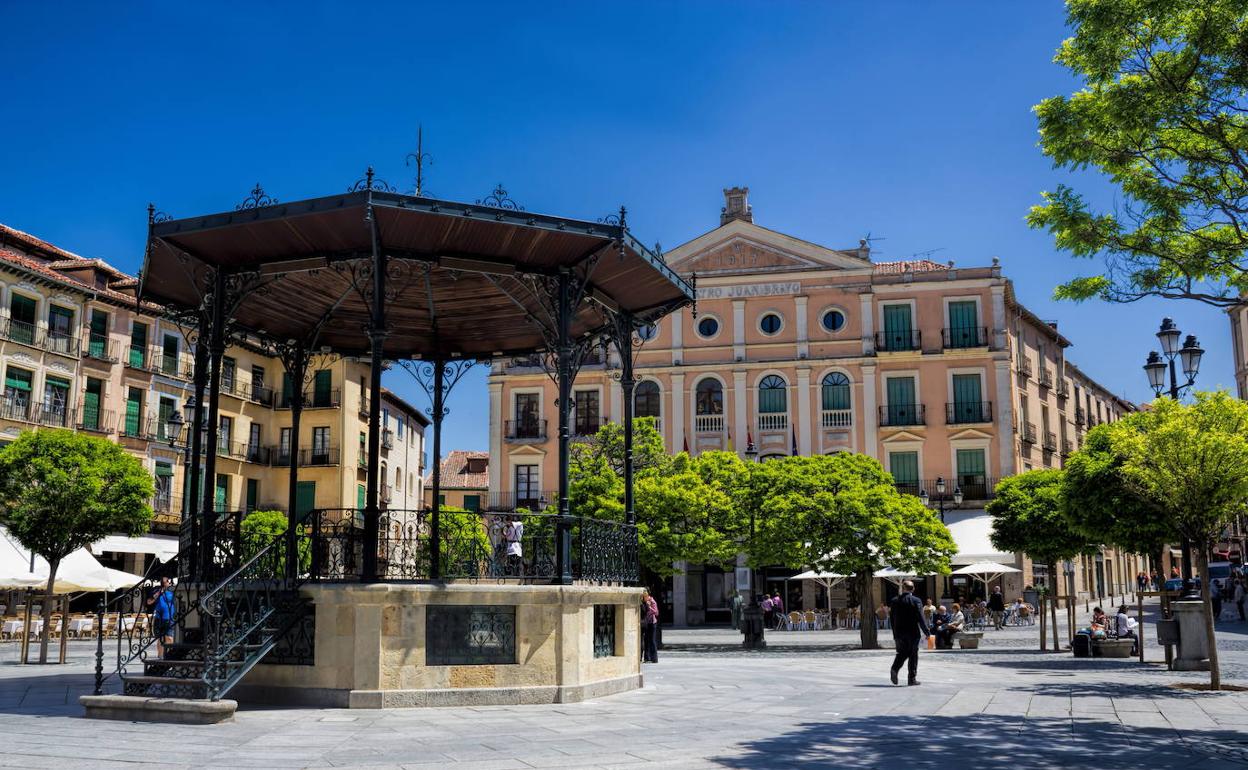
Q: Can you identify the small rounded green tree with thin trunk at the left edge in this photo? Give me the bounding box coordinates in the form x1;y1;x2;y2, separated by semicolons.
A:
0;431;155;663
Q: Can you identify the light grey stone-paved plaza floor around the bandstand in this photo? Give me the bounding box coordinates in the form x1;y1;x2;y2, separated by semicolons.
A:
0;606;1248;770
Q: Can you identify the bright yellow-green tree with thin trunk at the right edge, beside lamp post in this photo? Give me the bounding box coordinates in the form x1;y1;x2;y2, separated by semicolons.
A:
1063;392;1248;690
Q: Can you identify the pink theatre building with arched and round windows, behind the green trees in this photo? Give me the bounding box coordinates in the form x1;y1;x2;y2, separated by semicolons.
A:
489;187;1134;624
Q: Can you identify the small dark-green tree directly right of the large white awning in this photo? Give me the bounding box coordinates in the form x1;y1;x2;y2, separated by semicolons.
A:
985;469;1090;650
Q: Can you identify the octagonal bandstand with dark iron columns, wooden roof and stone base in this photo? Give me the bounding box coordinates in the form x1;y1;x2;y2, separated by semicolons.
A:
85;175;693;718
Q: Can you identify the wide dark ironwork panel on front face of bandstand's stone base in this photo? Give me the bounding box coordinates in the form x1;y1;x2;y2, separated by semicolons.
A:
424;604;515;665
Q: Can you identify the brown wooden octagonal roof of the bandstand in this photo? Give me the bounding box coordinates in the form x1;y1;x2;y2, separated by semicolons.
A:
140;190;693;358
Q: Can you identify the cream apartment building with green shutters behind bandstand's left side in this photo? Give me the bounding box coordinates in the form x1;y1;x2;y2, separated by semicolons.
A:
0;225;429;546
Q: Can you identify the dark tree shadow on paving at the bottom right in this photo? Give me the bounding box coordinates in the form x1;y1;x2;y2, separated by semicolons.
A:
711;714;1248;770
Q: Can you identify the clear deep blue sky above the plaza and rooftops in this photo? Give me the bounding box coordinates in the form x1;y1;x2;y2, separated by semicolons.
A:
0;1;1233;449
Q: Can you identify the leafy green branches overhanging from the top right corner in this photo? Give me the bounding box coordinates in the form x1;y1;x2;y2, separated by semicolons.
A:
1027;0;1248;307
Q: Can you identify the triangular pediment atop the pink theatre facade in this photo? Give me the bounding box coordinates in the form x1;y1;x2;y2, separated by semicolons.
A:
666;220;871;276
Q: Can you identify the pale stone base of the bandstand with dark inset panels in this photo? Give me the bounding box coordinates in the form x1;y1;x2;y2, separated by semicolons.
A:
231;583;641;709
